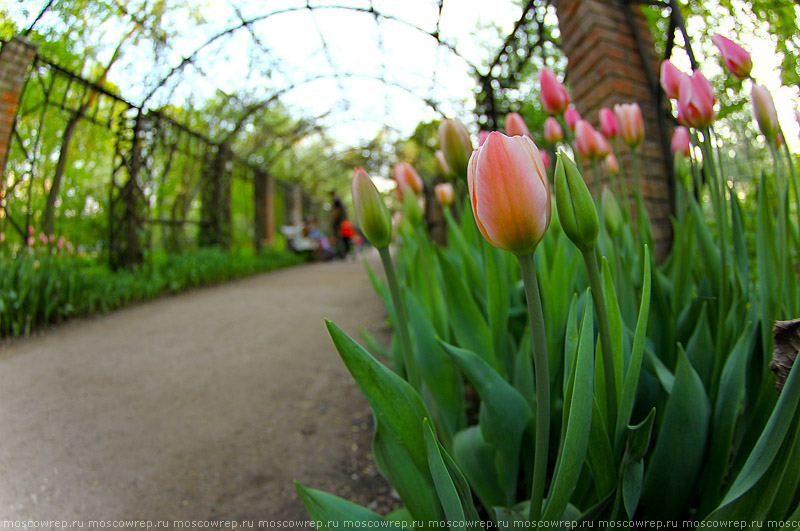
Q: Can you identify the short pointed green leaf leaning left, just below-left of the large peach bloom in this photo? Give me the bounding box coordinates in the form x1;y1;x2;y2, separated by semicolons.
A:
439;254;494;374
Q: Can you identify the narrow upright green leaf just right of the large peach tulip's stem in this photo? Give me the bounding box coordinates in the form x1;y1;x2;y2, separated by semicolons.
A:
542;297;594;521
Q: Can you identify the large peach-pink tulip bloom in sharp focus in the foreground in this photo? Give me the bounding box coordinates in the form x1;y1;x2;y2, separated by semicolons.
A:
467;132;550;255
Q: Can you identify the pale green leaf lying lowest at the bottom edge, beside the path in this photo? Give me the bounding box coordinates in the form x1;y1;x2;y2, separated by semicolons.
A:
294;481;394;530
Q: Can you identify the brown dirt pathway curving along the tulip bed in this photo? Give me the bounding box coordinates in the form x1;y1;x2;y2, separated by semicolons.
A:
0;252;388;527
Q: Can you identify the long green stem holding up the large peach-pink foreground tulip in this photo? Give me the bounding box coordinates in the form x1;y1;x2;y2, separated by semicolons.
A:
517;253;550;522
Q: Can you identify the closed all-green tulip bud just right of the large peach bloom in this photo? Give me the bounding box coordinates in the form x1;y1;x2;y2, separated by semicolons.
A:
555;151;600;250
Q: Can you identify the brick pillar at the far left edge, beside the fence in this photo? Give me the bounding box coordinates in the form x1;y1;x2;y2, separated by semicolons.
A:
0;36;36;196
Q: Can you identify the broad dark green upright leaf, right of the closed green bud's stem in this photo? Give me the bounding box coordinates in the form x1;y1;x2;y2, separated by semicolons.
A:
642;347;711;520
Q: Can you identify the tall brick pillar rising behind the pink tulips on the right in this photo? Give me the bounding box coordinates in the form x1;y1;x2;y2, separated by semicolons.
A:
554;0;673;259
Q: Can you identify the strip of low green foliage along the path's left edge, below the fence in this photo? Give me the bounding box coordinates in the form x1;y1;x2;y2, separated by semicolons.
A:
0;244;299;337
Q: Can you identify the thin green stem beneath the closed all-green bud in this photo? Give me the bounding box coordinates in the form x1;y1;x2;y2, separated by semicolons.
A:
581;245;617;434
